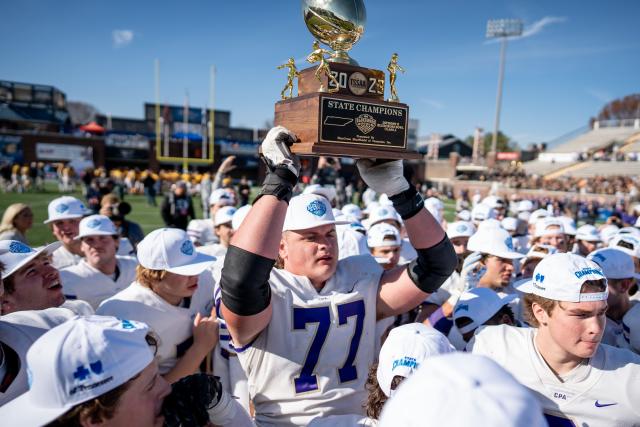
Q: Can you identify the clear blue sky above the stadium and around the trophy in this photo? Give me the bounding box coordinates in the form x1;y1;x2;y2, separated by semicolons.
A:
0;0;640;144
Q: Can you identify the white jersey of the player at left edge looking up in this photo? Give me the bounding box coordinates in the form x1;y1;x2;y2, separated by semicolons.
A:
0;307;76;406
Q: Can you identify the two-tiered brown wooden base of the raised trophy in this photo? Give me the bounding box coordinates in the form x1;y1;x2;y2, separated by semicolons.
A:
274;63;422;159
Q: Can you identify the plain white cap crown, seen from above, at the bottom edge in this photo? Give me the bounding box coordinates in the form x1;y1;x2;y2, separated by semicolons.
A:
378;352;547;427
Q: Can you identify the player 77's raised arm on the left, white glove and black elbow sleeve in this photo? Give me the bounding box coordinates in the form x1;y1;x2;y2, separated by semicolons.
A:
220;126;300;346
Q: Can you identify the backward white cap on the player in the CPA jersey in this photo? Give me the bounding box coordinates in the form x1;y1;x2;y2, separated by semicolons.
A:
517;253;609;302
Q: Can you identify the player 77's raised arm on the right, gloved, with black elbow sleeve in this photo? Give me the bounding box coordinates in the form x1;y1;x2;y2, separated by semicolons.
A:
357;160;457;319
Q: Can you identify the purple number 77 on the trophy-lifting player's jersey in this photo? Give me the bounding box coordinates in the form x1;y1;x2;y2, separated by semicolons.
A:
293;300;364;393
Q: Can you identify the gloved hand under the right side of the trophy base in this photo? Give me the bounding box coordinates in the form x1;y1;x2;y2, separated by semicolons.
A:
356;159;409;197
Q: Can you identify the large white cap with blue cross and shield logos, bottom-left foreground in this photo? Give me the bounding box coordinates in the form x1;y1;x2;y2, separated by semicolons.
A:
0;316;154;426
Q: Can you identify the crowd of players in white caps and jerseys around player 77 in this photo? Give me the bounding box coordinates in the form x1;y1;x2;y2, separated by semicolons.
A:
0;127;640;426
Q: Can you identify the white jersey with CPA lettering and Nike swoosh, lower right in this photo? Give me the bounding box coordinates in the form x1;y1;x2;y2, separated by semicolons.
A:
469;325;640;427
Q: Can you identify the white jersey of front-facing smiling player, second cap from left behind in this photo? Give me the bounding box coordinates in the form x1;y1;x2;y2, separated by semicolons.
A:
60;255;138;309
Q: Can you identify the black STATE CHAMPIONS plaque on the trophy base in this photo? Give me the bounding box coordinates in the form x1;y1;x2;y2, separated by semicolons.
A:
320;96;409;148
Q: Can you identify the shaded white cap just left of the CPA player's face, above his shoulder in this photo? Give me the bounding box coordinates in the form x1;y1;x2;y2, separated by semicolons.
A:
453;288;518;334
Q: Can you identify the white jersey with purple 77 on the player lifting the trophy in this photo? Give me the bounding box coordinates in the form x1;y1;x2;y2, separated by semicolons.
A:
236;255;383;426
